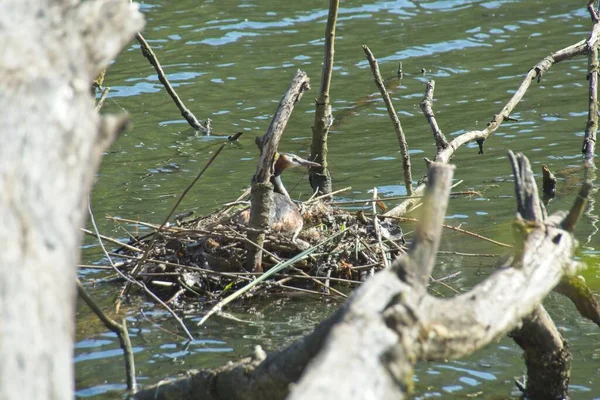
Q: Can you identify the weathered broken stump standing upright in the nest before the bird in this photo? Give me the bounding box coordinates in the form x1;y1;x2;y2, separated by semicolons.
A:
246;71;310;271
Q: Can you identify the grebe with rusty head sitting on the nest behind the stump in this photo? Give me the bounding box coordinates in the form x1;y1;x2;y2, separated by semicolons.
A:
234;153;321;237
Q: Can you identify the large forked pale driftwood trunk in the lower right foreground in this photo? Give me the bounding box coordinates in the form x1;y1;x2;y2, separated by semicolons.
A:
136;154;592;399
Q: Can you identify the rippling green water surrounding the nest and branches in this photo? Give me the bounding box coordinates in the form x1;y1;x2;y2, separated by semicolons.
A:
75;0;600;399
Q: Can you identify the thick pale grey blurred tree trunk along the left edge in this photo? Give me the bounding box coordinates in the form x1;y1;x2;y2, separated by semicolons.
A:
0;0;143;399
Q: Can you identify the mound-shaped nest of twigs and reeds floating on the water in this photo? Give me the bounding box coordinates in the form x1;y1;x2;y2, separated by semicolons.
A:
110;201;405;306
